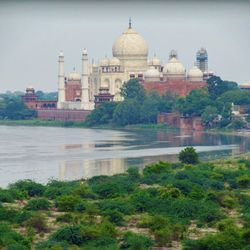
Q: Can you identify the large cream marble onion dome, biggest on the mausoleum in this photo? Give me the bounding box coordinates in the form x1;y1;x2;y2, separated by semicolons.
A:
112;27;148;58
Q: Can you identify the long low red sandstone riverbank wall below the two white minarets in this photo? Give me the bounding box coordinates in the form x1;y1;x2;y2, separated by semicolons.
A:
37;109;90;121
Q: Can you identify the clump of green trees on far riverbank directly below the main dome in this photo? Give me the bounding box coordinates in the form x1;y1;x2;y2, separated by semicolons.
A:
86;79;177;126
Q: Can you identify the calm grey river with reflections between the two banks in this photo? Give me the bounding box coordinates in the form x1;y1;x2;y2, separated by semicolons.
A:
0;126;250;187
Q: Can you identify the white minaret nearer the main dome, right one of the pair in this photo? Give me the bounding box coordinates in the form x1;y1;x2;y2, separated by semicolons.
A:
81;49;91;110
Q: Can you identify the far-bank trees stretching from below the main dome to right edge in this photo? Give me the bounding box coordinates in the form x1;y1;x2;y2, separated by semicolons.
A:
87;76;250;129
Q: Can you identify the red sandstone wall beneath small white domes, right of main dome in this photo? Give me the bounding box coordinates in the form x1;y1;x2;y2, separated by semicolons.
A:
141;80;206;96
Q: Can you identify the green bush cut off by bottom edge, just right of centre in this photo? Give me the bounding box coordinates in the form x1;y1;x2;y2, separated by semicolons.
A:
121;232;153;250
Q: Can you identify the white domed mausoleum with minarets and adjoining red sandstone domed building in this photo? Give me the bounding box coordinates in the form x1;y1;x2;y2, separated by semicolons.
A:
53;20;211;109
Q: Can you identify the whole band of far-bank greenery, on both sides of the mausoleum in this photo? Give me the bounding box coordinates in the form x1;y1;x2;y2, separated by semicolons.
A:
0;76;250;130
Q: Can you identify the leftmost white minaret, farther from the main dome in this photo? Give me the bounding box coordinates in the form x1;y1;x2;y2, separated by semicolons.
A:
57;51;65;109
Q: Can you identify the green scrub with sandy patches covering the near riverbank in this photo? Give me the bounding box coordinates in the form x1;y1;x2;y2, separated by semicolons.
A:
0;148;250;250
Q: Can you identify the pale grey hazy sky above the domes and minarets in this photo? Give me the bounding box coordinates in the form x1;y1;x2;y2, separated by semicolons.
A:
0;0;250;92
